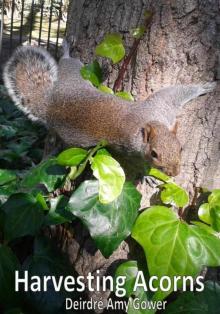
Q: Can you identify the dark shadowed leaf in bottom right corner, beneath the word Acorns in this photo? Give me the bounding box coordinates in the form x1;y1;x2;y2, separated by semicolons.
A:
165;281;220;314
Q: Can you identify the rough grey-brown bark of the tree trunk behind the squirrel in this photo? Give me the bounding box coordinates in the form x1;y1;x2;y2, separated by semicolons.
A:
57;0;220;310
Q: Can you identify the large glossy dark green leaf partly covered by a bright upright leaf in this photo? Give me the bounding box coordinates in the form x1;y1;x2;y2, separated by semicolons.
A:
68;180;141;257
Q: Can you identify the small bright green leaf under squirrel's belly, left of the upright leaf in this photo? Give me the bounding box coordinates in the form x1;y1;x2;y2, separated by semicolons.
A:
57;148;88;167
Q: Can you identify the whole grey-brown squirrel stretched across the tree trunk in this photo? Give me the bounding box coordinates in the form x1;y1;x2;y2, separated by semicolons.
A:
3;46;216;176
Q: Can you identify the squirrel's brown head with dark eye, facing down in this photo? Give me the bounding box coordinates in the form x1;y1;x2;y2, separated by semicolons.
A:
143;121;182;176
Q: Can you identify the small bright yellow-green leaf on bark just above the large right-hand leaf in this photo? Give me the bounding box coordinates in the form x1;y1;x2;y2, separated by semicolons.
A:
160;183;189;207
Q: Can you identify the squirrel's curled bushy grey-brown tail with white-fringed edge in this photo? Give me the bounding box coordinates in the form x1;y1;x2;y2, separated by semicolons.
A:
3;46;57;119
